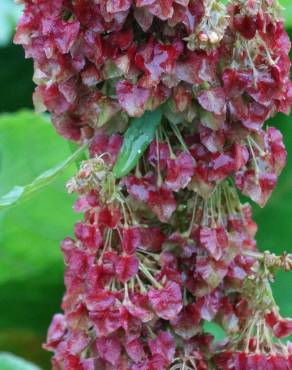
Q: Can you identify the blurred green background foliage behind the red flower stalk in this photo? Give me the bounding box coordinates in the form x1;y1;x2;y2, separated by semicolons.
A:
0;0;292;370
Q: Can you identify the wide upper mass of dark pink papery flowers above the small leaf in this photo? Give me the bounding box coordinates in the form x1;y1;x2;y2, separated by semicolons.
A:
15;0;292;205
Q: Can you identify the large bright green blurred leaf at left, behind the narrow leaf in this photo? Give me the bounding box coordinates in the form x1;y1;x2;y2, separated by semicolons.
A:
0;111;76;284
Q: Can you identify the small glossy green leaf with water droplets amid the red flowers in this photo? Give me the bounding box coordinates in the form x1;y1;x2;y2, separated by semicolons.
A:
114;108;162;178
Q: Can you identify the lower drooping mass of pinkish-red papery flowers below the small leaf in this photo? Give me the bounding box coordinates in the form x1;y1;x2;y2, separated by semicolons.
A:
42;141;255;370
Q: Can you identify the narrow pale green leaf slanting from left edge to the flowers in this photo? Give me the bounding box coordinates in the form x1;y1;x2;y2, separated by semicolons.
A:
0;146;86;210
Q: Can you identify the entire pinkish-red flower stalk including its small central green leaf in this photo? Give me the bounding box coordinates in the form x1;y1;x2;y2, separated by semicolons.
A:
15;0;292;370
